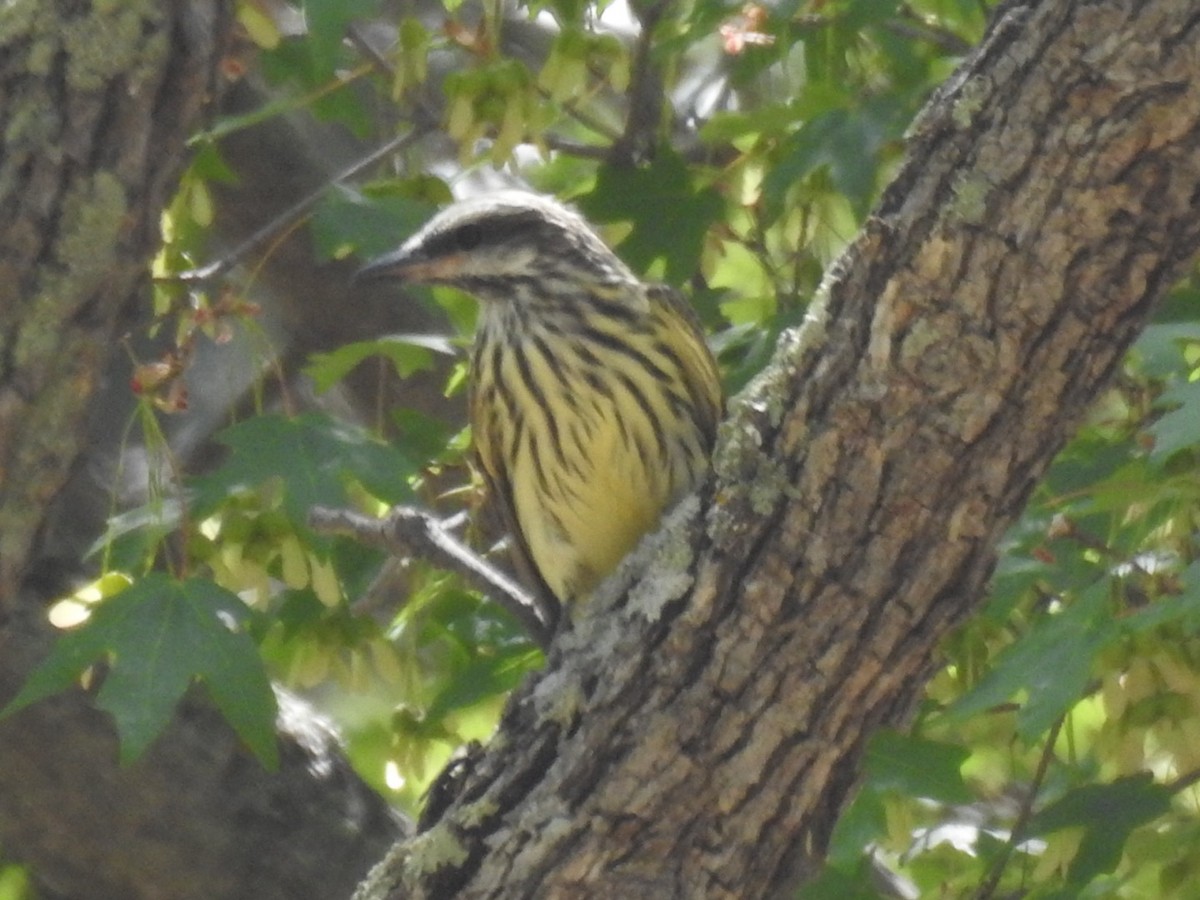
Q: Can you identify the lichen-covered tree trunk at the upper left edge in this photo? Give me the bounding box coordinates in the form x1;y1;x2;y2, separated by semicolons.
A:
0;1;224;592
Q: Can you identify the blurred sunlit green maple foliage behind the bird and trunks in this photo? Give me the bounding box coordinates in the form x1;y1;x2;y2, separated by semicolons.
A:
9;0;1200;899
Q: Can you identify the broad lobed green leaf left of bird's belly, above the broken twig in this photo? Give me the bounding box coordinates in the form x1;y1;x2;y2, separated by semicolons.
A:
192;413;421;533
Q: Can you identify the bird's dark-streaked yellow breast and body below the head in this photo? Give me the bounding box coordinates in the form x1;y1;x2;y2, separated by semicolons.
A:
470;286;721;602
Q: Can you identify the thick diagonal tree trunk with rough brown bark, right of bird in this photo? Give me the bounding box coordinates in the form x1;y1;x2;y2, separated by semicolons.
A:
376;0;1200;900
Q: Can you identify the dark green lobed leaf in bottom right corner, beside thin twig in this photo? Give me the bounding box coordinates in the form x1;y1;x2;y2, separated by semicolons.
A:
1028;773;1171;886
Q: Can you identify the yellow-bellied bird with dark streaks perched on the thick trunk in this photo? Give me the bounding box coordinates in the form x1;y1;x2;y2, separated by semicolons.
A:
359;191;722;628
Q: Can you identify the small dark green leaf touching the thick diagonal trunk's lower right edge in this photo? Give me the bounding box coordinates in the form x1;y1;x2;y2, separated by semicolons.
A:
864;731;972;803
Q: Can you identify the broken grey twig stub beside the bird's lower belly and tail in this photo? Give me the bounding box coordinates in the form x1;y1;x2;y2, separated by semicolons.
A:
308;506;553;650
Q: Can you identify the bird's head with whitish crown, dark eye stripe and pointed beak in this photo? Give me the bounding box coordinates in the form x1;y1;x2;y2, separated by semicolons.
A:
355;191;636;302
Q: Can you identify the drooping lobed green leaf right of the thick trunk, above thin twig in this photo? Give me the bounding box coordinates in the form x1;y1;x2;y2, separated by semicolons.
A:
947;580;1120;740
